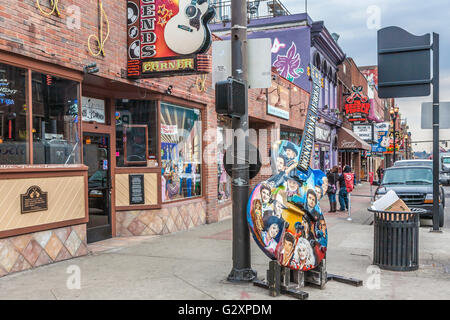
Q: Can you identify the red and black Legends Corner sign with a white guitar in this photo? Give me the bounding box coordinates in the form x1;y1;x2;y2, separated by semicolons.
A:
127;0;215;78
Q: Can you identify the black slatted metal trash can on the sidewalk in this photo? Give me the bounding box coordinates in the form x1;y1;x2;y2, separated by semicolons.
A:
368;209;425;271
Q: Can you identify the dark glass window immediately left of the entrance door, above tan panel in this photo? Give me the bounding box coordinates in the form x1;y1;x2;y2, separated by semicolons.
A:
32;72;81;164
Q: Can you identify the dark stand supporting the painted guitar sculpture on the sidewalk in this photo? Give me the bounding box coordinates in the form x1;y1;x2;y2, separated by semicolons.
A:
253;259;363;300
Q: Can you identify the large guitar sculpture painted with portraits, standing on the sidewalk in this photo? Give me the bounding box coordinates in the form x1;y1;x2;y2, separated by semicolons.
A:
247;66;328;271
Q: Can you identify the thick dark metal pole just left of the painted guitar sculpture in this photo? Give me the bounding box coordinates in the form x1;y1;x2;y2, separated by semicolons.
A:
228;0;256;281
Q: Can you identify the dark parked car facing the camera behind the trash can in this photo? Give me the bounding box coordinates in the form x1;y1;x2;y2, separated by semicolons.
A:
374;166;445;228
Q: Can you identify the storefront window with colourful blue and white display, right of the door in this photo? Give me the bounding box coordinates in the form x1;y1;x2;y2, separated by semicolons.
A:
161;103;202;202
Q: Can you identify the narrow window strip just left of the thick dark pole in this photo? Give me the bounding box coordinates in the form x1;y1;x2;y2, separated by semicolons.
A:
217;116;232;202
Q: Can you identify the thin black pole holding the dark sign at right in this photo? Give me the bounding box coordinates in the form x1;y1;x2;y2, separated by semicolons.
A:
432;32;439;231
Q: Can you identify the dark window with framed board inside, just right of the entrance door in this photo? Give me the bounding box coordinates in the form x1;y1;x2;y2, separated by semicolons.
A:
116;99;158;167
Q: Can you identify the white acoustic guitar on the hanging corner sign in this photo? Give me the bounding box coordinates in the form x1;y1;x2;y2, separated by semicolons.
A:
164;0;215;55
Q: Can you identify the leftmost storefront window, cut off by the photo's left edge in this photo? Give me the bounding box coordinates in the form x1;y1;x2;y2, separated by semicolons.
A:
0;63;29;165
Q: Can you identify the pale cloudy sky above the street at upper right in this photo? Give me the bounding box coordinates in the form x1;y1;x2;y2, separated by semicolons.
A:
281;0;450;151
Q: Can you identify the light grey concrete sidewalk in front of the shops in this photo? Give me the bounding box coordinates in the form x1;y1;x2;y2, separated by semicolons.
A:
0;186;450;300
